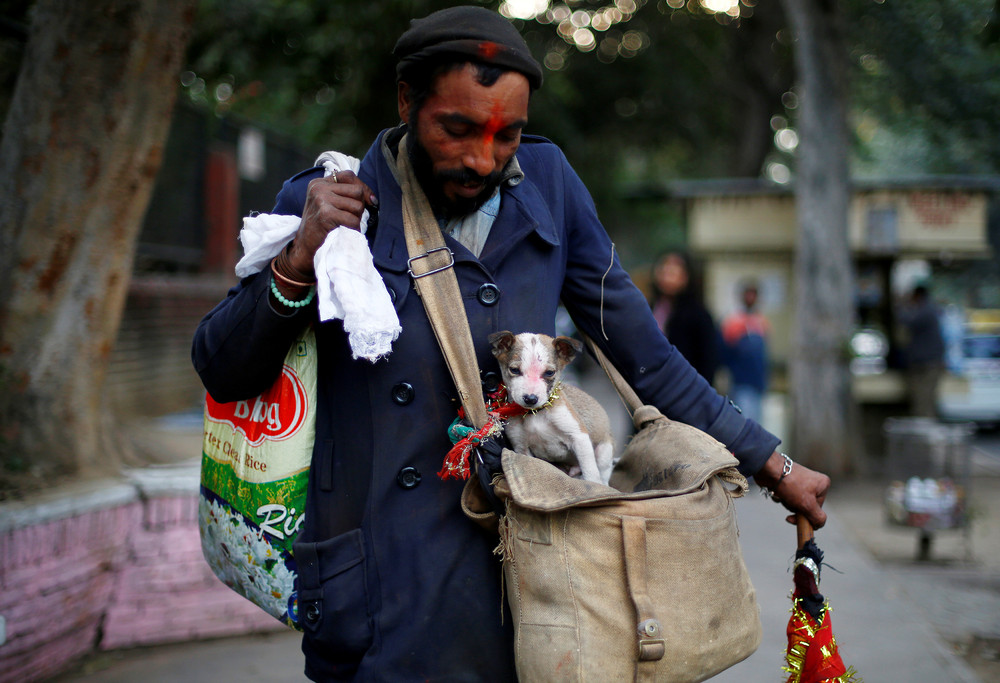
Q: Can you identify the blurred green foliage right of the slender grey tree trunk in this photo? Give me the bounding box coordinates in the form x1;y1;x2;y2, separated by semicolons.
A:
847;0;1000;173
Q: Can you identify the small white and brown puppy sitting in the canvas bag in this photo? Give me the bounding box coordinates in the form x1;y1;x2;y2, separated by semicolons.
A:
489;331;614;484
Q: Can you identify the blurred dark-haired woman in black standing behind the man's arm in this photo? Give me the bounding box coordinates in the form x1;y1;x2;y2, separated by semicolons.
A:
650;251;719;384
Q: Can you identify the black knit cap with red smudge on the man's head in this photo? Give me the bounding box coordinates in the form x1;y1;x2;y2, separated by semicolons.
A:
392;6;542;90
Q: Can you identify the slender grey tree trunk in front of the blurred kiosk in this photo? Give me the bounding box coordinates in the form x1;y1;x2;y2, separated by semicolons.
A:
783;0;855;474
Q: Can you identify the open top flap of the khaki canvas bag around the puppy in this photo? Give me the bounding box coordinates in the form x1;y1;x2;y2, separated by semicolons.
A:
496;406;747;512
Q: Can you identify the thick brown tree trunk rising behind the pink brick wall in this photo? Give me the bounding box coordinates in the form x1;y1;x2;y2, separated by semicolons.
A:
0;0;195;486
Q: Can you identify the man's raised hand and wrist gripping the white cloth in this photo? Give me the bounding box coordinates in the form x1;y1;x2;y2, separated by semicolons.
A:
288;171;378;279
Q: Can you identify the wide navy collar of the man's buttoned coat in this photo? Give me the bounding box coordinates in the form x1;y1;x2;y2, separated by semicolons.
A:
359;126;559;272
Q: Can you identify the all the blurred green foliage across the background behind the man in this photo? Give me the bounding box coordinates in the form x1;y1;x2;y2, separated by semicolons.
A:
183;0;1000;262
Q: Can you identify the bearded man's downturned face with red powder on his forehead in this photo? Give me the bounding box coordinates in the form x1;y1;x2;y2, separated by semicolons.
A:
399;64;530;216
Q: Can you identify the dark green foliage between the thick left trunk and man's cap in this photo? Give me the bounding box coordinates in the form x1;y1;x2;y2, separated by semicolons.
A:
183;0;468;155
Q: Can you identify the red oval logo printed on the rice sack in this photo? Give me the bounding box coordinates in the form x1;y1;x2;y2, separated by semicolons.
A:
205;365;309;446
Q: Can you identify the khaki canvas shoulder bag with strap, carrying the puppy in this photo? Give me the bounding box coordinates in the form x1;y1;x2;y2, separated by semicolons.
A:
397;143;761;683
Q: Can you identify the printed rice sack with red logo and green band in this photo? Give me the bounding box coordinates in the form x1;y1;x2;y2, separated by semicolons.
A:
199;327;316;629
